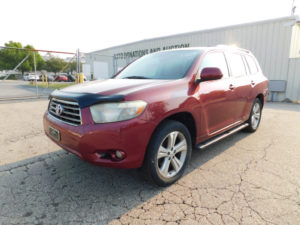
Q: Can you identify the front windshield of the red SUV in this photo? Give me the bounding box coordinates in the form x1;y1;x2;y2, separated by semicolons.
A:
116;50;201;80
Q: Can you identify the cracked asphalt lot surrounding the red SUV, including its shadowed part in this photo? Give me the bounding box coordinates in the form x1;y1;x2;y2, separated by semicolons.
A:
0;101;300;225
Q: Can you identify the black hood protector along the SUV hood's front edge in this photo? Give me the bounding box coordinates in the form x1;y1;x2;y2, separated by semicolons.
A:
49;90;124;108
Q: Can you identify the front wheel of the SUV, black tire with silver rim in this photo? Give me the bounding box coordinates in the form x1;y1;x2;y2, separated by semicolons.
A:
142;120;192;187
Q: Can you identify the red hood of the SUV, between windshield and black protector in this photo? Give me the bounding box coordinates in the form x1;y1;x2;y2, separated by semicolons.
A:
62;79;172;95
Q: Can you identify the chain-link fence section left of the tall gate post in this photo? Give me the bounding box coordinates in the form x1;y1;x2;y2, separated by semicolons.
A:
0;46;83;100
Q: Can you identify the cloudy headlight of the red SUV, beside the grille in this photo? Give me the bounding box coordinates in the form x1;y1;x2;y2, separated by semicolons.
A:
90;100;147;123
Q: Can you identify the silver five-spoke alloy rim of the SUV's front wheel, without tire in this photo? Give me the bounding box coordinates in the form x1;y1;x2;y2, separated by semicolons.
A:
156;131;187;178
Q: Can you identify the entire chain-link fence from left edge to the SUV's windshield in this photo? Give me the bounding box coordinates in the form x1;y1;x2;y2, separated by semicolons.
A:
0;46;147;101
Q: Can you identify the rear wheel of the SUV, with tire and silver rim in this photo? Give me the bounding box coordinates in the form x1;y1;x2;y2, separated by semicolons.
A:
245;98;262;133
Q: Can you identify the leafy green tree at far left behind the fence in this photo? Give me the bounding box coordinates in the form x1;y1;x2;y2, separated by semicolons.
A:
0;41;45;74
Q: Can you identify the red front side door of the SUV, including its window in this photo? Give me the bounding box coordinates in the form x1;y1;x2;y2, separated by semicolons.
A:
199;51;235;136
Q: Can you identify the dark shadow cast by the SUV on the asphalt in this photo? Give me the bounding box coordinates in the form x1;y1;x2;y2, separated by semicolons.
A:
0;132;249;224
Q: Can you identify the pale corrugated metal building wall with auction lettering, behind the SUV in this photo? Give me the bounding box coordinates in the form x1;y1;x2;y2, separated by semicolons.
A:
87;17;300;101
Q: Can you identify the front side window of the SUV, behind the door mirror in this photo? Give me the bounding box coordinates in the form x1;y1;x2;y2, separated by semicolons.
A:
200;52;228;77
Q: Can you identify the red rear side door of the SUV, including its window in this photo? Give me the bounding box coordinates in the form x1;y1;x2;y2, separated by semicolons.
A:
226;52;251;122
